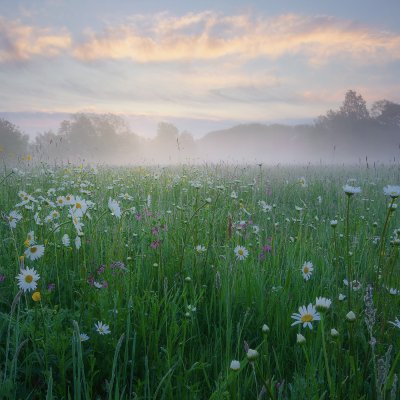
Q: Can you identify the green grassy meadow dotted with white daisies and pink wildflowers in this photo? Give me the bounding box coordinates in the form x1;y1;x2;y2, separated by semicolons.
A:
0;165;400;400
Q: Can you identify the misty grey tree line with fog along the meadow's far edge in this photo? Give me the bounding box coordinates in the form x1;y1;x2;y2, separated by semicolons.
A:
0;90;400;164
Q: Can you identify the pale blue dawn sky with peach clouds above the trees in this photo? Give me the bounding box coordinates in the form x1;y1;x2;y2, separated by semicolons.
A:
0;0;400;137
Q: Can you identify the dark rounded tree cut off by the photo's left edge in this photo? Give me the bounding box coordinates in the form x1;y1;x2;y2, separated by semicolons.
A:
0;118;29;158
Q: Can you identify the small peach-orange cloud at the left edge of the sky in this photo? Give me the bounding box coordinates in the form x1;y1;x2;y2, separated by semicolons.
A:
0;16;72;63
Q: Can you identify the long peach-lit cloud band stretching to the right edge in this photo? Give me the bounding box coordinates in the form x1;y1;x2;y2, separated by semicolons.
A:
74;11;400;65
